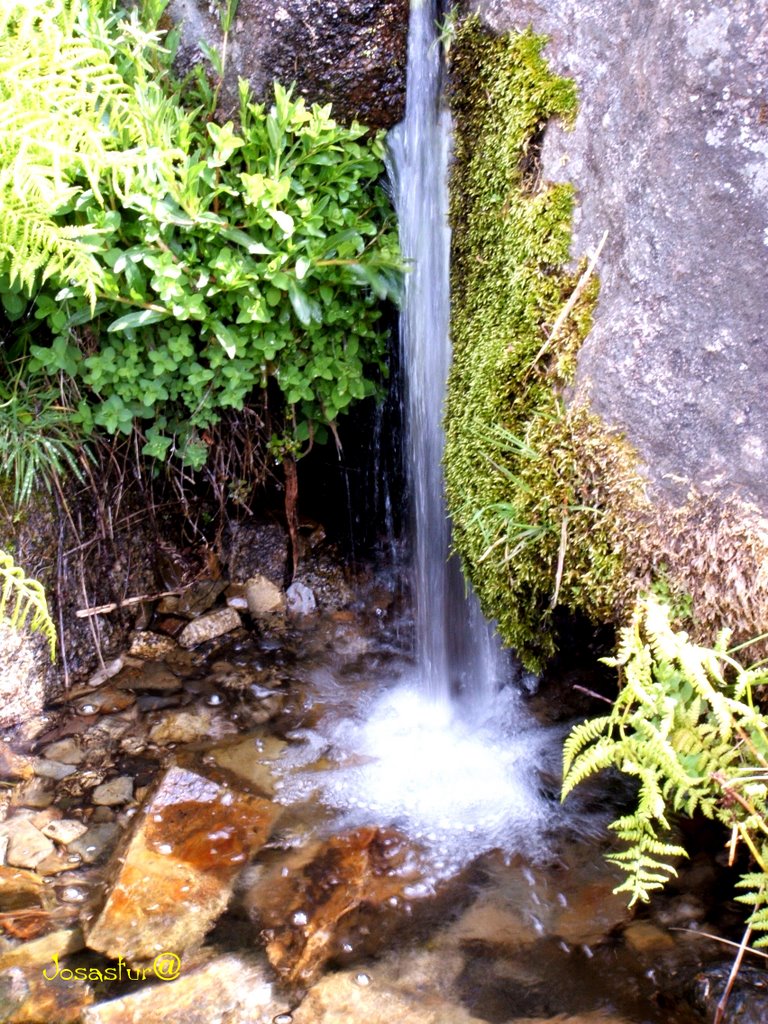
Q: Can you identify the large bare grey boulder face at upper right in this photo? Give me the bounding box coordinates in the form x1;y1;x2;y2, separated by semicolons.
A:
476;0;768;510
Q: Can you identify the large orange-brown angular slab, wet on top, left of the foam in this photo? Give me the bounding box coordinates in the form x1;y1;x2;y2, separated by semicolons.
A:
81;767;281;962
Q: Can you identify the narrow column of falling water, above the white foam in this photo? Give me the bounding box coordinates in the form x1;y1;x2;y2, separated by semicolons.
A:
389;0;504;711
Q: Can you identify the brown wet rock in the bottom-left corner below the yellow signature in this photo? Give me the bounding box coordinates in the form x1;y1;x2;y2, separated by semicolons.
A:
0;967;93;1024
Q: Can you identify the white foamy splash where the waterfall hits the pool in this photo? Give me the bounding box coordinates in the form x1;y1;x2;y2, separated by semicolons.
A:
278;676;562;876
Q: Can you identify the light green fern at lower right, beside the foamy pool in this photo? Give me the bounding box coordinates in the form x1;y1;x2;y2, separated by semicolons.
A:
562;594;768;945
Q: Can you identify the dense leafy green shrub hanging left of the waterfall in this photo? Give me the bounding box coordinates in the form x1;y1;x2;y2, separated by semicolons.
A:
0;0;400;468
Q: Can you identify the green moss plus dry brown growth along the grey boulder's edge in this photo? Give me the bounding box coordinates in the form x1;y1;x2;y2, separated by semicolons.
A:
445;17;768;669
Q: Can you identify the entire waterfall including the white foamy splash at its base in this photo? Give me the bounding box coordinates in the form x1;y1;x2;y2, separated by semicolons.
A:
276;0;559;873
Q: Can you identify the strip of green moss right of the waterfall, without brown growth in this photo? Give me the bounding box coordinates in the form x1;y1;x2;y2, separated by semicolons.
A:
445;18;640;668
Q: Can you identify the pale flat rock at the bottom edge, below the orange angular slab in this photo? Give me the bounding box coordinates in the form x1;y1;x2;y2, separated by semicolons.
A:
83;954;284;1024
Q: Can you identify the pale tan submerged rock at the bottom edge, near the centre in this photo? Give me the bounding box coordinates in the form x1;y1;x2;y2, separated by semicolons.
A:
293;970;480;1024
